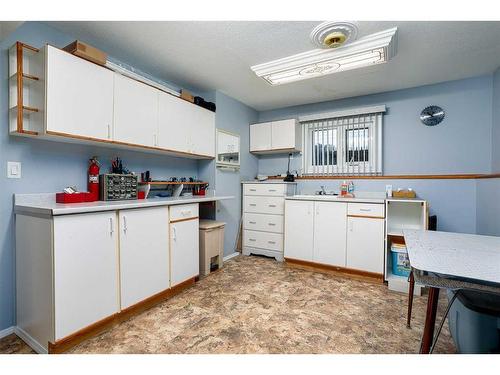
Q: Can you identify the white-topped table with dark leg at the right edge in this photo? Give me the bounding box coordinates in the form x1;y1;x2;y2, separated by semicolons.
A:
403;230;500;353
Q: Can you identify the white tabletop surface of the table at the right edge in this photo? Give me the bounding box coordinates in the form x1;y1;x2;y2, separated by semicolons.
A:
403;229;500;283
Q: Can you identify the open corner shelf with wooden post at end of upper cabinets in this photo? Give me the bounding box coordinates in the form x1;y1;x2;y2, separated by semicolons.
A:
9;42;45;136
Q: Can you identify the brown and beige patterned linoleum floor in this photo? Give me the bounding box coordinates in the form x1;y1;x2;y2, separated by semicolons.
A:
0;256;455;353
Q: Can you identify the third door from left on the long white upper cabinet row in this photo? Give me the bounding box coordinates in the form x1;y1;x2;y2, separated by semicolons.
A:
158;92;193;153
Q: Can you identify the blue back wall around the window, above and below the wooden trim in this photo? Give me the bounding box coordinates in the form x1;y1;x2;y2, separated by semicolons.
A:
259;75;492;233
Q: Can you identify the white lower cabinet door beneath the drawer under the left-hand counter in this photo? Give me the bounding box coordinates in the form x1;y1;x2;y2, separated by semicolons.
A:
170;219;200;286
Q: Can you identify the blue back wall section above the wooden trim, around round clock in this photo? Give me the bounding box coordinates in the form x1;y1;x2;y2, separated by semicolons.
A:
259;75;492;175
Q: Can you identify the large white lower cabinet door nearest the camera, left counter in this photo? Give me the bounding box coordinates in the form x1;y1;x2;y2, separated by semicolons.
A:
54;211;119;340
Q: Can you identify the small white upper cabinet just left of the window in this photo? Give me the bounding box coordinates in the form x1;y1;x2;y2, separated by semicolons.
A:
250;119;302;154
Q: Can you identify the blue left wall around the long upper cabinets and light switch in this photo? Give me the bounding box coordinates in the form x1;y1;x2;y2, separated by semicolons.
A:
0;22;205;330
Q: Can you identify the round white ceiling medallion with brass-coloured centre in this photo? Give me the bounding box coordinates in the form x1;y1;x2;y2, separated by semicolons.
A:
310;21;358;48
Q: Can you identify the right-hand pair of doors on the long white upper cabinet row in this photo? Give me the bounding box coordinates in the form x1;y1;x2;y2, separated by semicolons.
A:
158;92;215;157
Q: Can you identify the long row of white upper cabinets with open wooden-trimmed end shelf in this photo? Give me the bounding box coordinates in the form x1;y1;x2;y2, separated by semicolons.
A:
9;43;215;159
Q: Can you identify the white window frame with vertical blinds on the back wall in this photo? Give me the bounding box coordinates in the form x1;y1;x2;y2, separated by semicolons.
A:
299;106;385;176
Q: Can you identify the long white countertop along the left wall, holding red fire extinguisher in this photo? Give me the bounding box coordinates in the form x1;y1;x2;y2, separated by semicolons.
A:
14;193;234;216
